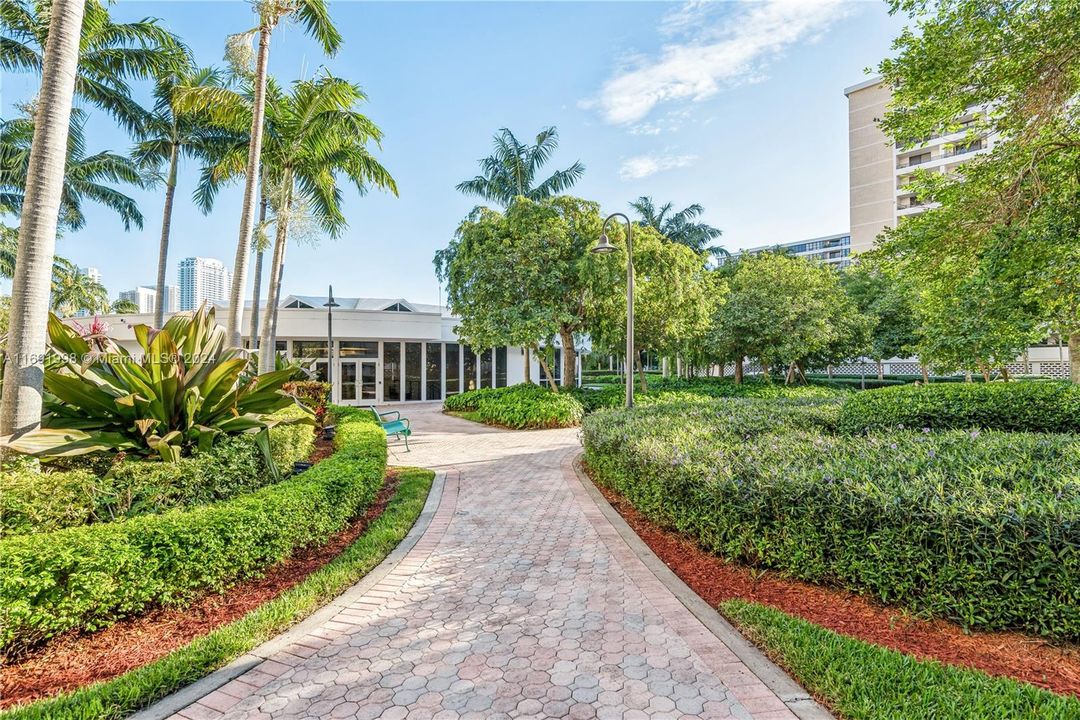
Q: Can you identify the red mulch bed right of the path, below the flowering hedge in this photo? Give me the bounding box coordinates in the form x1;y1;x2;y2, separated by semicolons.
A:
597;485;1080;696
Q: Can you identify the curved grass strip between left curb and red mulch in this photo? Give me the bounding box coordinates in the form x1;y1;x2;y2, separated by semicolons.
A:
0;467;434;720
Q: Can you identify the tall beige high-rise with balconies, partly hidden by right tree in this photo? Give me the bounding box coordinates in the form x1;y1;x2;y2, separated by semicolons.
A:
843;78;994;253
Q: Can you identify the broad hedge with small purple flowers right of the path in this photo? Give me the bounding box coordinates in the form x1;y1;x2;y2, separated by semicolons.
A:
583;399;1080;641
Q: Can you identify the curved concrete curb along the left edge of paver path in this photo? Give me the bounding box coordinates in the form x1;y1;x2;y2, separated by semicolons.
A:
129;473;446;720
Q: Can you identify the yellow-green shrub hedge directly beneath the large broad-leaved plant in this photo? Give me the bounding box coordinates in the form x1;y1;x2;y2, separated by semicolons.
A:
0;406;314;535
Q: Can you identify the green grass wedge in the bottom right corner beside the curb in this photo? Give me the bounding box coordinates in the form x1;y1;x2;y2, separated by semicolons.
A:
720;600;1080;720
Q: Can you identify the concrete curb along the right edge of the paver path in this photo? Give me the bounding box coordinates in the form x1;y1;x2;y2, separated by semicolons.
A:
571;453;833;720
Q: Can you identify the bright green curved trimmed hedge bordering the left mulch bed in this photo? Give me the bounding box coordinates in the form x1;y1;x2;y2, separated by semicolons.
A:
0;408;387;654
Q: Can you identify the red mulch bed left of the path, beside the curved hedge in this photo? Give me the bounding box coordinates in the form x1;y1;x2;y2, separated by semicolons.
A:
0;436;399;708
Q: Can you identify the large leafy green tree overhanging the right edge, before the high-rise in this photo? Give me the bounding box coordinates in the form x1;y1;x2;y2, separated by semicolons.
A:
880;0;1080;382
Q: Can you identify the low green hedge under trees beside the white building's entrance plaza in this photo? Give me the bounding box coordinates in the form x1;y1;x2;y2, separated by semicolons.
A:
443;383;585;429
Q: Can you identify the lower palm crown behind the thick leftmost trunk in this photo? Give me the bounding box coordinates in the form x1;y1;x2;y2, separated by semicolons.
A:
0;109;148;230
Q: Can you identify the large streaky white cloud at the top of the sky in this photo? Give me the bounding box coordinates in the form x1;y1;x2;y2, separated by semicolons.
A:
581;0;847;125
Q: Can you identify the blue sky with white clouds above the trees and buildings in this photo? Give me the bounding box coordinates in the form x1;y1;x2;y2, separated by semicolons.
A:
0;0;901;302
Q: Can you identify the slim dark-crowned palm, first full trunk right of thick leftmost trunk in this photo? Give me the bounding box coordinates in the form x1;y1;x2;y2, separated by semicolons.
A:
134;67;247;327
